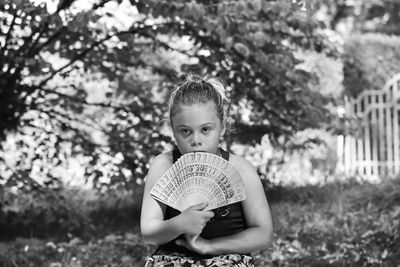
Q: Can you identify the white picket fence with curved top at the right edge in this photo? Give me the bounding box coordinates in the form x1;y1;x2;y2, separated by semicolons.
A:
338;74;400;176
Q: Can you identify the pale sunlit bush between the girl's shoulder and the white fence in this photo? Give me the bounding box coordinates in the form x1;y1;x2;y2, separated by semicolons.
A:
232;129;338;186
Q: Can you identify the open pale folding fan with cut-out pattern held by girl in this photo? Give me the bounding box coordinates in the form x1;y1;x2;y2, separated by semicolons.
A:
150;152;246;211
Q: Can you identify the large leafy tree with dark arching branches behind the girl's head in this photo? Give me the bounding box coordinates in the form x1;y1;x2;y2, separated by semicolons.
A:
0;0;334;191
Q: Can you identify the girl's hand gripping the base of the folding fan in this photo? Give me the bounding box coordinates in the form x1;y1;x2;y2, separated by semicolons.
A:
177;203;214;235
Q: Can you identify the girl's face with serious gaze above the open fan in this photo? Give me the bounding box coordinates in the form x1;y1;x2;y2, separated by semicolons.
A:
171;101;225;154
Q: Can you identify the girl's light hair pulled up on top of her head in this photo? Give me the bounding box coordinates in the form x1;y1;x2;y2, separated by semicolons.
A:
169;74;228;128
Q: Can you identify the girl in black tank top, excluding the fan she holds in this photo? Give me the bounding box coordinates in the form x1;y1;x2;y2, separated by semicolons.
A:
141;76;272;266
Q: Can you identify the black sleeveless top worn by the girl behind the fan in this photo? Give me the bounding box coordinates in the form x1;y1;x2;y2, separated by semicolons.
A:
155;149;247;257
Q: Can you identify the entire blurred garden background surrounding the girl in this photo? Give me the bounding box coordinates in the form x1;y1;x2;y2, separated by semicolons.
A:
0;0;400;267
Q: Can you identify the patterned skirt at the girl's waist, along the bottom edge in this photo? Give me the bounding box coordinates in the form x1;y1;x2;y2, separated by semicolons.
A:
145;254;254;267
